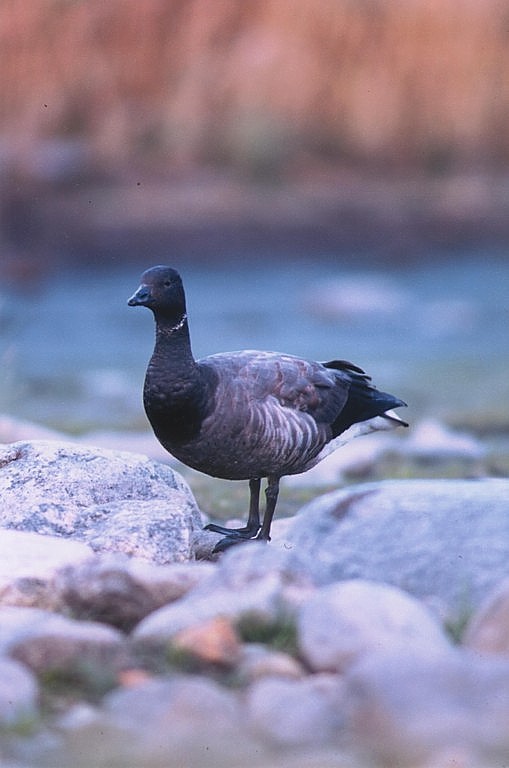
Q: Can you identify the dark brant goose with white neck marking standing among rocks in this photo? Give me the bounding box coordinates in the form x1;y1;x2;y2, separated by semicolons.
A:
128;266;408;551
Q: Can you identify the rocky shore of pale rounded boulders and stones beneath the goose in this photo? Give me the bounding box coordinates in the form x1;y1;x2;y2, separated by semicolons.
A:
0;435;509;768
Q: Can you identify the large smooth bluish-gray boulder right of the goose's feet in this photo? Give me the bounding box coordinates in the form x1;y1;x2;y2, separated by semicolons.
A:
284;479;509;617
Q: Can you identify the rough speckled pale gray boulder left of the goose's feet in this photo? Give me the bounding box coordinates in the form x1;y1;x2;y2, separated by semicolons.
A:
0;440;202;563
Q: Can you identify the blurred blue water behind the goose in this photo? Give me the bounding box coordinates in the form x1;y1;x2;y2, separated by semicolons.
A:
0;253;509;431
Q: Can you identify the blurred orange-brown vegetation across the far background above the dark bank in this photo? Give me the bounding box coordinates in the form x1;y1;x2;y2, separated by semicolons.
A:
0;0;509;171
